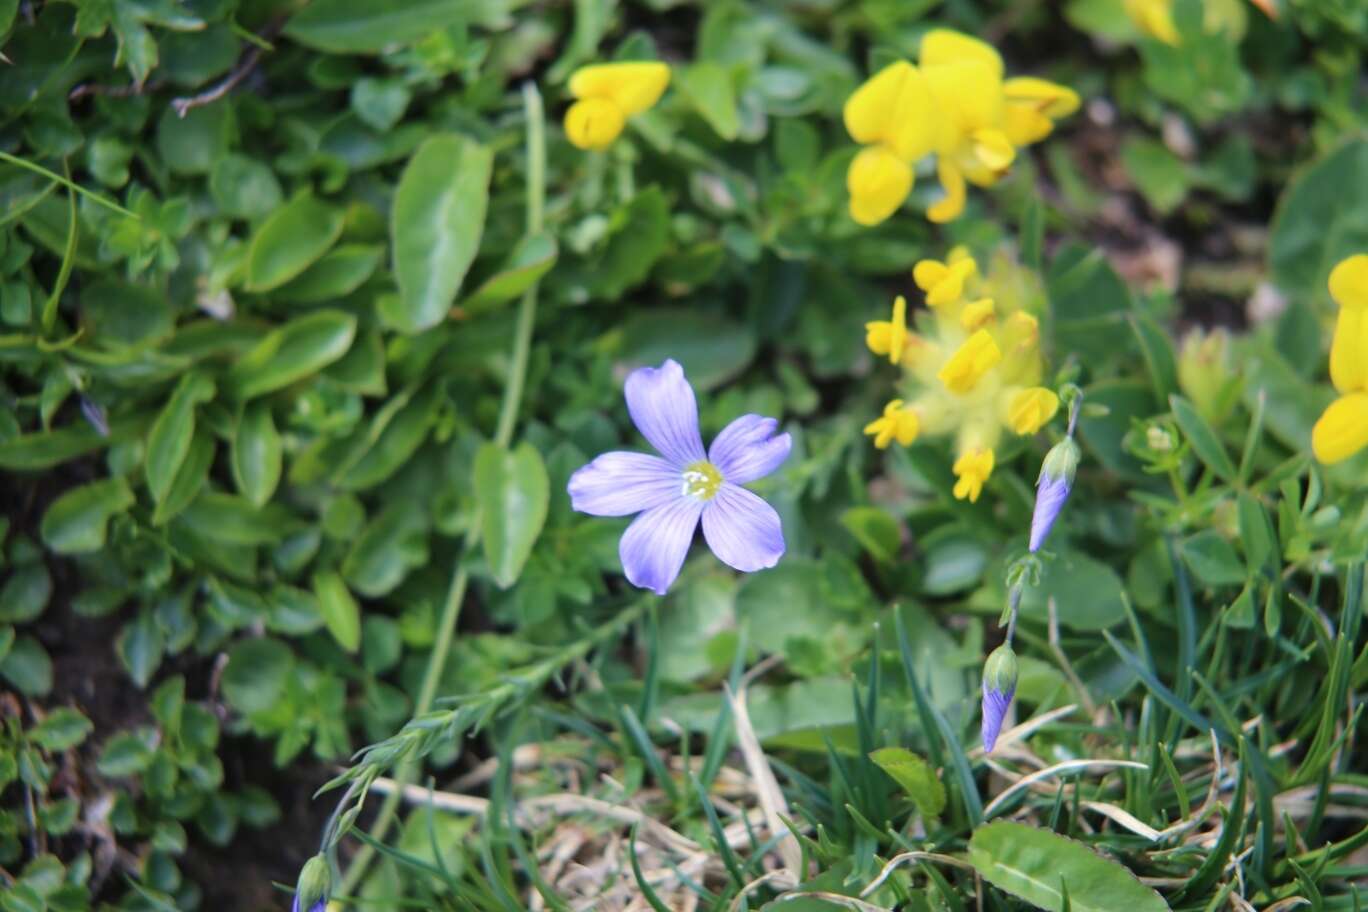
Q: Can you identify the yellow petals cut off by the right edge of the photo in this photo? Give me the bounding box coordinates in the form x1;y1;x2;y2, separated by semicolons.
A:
1311;253;1368;465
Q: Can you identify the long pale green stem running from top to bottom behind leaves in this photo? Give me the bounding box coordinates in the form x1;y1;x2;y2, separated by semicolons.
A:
337;82;546;896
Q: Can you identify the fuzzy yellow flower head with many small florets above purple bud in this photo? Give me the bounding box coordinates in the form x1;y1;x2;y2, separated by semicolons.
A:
865;247;1059;500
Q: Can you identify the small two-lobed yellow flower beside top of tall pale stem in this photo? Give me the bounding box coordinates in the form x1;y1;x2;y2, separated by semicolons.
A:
565;60;670;149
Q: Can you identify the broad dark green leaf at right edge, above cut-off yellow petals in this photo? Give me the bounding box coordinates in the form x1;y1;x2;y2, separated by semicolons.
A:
1250;139;1368;304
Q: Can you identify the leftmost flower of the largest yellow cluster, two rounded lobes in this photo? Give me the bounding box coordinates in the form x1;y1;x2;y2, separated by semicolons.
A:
843;60;932;226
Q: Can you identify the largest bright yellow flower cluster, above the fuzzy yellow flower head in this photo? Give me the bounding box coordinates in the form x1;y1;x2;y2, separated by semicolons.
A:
844;29;1078;226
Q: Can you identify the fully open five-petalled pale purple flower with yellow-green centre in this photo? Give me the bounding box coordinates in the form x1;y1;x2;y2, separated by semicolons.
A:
569;360;793;595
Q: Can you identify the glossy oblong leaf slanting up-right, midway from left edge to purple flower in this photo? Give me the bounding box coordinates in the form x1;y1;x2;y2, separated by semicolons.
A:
224;310;356;399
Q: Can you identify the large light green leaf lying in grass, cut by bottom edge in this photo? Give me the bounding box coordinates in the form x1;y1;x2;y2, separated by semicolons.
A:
969;820;1168;912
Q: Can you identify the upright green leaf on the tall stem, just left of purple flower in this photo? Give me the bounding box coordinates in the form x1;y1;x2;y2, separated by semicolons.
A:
475;443;551;589
